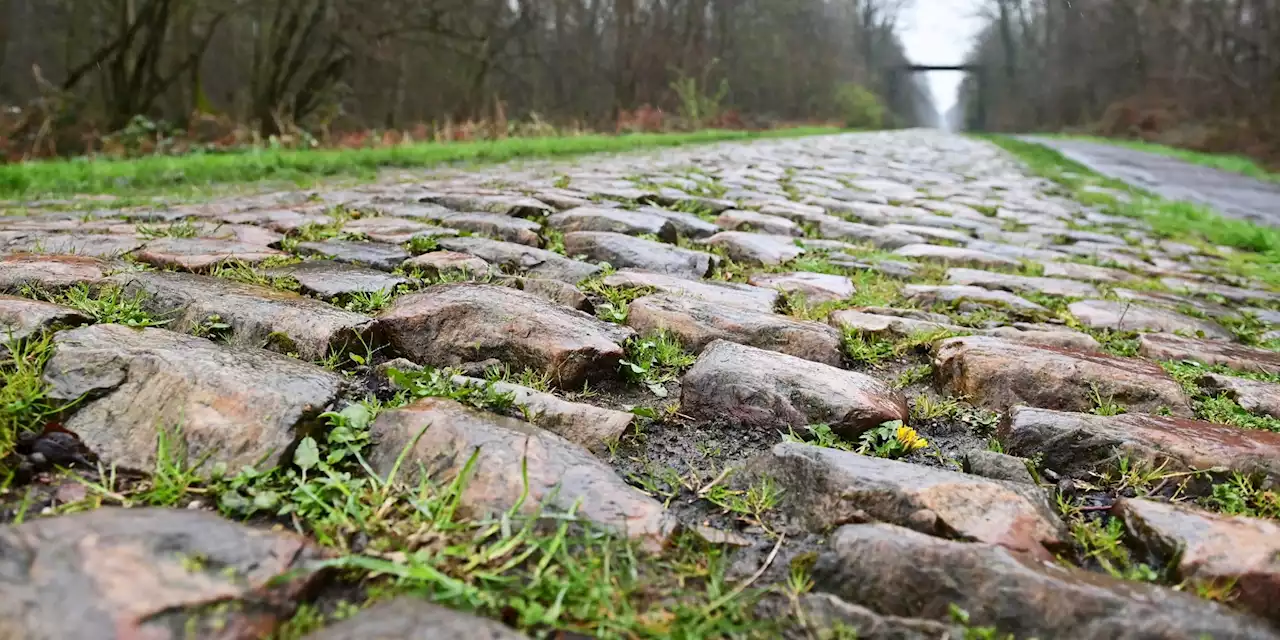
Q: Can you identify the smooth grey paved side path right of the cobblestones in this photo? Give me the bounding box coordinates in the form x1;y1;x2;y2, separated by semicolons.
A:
1023;136;1280;227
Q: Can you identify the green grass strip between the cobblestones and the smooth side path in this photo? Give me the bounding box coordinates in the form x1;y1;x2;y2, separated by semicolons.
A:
984;136;1280;288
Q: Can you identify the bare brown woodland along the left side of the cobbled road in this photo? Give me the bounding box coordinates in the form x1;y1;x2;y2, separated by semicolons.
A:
0;0;933;151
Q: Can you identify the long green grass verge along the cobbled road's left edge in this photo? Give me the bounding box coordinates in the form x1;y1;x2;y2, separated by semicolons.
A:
0;128;838;198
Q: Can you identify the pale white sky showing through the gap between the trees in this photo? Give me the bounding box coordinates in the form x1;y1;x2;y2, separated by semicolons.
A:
900;0;982;115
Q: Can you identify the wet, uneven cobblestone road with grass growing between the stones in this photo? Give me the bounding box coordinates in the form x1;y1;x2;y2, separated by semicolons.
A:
0;131;1280;639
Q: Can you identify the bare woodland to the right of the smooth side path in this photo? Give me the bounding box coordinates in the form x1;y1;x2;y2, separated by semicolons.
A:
952;0;1280;161
